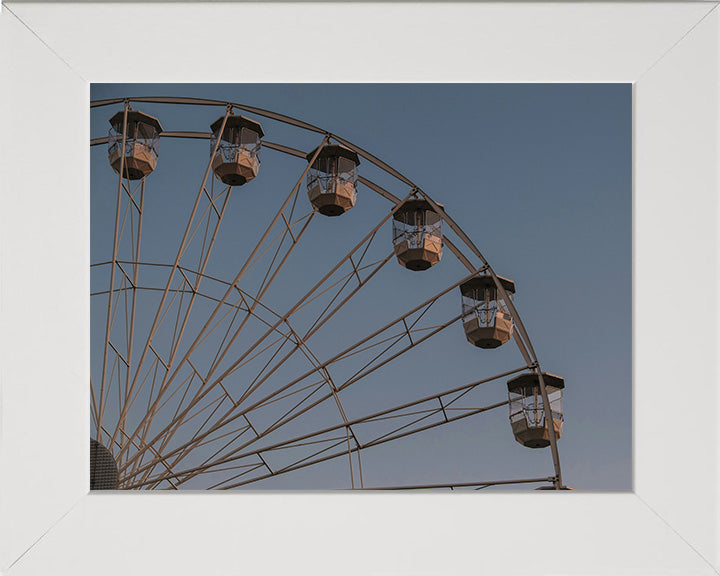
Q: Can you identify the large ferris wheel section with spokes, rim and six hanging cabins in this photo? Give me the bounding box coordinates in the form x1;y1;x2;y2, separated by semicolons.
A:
90;97;564;490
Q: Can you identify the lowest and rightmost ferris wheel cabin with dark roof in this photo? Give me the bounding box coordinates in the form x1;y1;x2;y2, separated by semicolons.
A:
507;372;565;448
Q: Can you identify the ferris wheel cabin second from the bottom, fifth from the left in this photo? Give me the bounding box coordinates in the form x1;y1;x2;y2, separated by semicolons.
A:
460;276;515;348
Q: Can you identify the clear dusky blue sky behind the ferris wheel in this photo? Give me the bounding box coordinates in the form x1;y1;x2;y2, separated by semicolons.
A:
91;84;632;490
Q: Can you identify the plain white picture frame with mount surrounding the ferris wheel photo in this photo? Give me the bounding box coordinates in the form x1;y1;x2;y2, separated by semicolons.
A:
0;2;720;576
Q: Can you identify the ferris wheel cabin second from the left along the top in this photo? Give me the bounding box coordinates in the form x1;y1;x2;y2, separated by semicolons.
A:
210;115;264;186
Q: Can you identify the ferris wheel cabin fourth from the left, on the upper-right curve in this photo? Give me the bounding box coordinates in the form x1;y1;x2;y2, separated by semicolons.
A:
393;200;442;271
